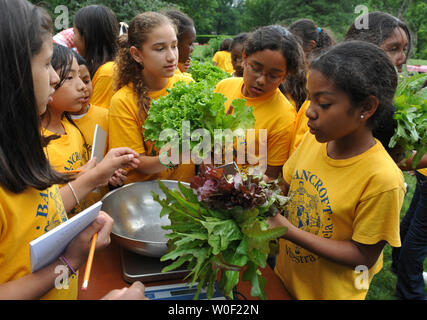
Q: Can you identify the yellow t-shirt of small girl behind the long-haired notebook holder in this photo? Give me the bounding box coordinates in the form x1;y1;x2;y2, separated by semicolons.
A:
42;119;88;173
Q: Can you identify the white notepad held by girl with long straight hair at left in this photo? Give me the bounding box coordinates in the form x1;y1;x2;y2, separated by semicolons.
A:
30;201;102;272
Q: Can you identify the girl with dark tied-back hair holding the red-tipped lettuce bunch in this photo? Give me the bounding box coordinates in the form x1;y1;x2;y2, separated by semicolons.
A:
268;41;405;299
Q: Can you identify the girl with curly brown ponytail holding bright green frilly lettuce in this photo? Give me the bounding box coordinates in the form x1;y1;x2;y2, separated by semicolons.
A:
109;12;195;183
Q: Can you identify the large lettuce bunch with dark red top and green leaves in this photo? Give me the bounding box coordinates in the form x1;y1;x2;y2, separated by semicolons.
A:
153;165;288;299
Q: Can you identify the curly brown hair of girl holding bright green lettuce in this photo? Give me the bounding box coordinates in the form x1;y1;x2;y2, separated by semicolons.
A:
115;12;176;119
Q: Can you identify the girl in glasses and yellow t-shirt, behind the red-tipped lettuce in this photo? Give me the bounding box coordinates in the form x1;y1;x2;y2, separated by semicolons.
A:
215;25;303;178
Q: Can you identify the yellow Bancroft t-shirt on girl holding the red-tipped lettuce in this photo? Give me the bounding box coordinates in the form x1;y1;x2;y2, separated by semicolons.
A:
275;134;405;300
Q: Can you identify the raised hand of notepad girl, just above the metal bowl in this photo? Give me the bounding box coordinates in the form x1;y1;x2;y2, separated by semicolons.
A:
93;147;139;185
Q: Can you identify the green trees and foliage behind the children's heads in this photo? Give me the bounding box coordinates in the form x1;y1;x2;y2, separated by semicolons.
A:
30;0;427;59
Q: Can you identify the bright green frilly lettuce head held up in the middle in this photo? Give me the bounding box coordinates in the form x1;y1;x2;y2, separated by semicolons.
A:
143;81;255;150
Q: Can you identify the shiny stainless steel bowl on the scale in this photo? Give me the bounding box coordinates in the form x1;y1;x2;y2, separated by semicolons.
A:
101;180;189;257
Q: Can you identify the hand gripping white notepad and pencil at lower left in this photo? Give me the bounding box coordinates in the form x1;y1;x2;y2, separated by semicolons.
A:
64;211;114;269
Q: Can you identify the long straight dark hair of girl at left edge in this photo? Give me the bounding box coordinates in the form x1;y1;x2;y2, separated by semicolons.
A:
0;0;69;194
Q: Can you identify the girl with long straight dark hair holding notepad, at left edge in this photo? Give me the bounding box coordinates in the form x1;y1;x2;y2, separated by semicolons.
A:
0;0;144;300
